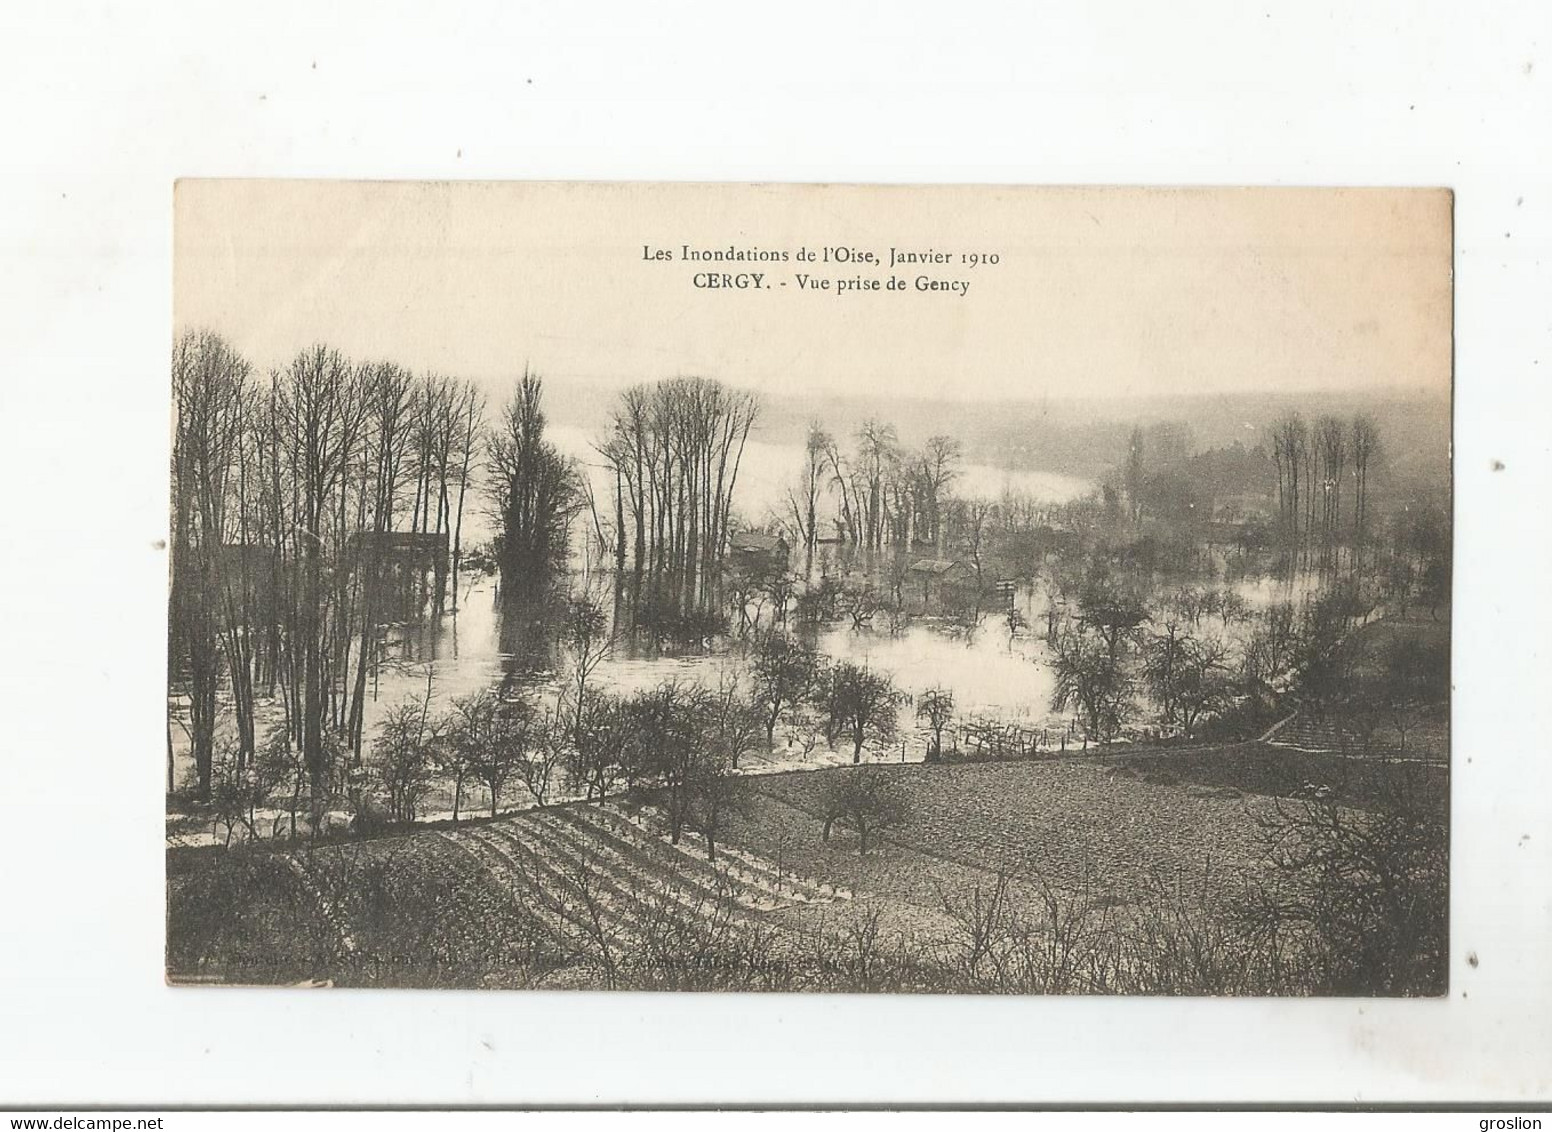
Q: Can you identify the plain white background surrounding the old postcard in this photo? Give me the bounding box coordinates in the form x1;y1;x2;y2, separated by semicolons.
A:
0;0;1552;1106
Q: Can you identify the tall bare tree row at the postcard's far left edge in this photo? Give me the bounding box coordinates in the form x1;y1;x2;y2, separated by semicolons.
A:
169;331;483;804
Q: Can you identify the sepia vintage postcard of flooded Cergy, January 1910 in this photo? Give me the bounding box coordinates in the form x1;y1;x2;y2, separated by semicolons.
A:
163;180;1453;995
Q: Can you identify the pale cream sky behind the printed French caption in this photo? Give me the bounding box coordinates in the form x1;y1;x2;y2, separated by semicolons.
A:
174;180;1451;399
